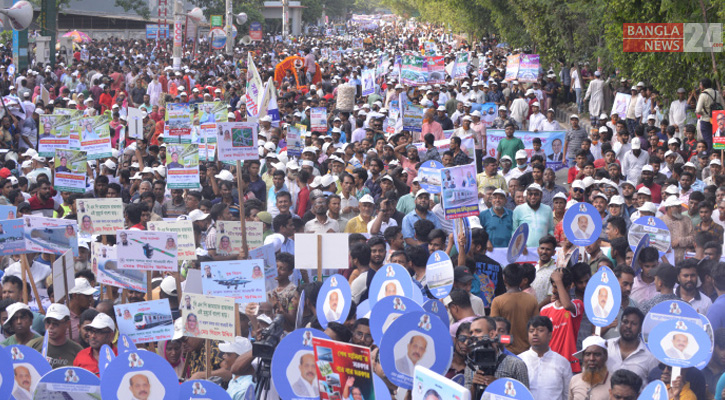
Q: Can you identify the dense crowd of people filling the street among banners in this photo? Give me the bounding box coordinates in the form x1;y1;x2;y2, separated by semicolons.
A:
0;17;725;400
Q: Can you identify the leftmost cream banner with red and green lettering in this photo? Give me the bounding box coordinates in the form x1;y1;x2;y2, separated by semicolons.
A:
76;198;124;241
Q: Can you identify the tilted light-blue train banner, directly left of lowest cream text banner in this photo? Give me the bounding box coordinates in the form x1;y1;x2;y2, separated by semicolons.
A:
113;299;174;344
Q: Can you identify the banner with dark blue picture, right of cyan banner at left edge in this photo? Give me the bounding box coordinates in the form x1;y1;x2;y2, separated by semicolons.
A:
23;215;78;257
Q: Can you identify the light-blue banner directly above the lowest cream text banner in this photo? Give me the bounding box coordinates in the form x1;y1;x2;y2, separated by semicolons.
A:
201;260;267;304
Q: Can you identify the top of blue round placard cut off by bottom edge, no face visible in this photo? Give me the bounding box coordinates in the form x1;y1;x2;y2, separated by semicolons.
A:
35;367;101;399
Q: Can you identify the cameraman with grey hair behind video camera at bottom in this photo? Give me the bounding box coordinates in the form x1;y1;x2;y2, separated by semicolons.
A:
465;317;529;393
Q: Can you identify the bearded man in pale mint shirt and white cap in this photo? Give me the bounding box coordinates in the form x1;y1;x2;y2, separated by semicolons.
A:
512;183;554;247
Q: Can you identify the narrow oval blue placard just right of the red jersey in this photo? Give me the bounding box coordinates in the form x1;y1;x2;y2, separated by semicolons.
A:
584;266;622;327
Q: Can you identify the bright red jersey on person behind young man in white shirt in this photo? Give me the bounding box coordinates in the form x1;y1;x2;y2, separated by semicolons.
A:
539;299;584;374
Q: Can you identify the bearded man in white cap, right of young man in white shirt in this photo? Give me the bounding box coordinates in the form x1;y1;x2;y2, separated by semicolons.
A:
569;336;612;400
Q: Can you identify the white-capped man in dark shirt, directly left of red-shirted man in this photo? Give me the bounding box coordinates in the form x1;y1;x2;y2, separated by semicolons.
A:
28;303;83;368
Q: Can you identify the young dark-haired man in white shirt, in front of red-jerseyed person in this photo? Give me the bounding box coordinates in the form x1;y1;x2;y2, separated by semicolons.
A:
519;315;572;400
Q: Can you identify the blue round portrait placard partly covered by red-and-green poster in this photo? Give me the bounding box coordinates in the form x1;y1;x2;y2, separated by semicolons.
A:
272;328;330;400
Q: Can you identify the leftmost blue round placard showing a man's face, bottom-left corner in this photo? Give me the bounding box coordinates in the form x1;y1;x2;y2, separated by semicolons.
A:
6;344;51;399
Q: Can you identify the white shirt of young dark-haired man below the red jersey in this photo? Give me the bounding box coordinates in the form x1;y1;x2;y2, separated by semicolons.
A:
519;349;572;400
